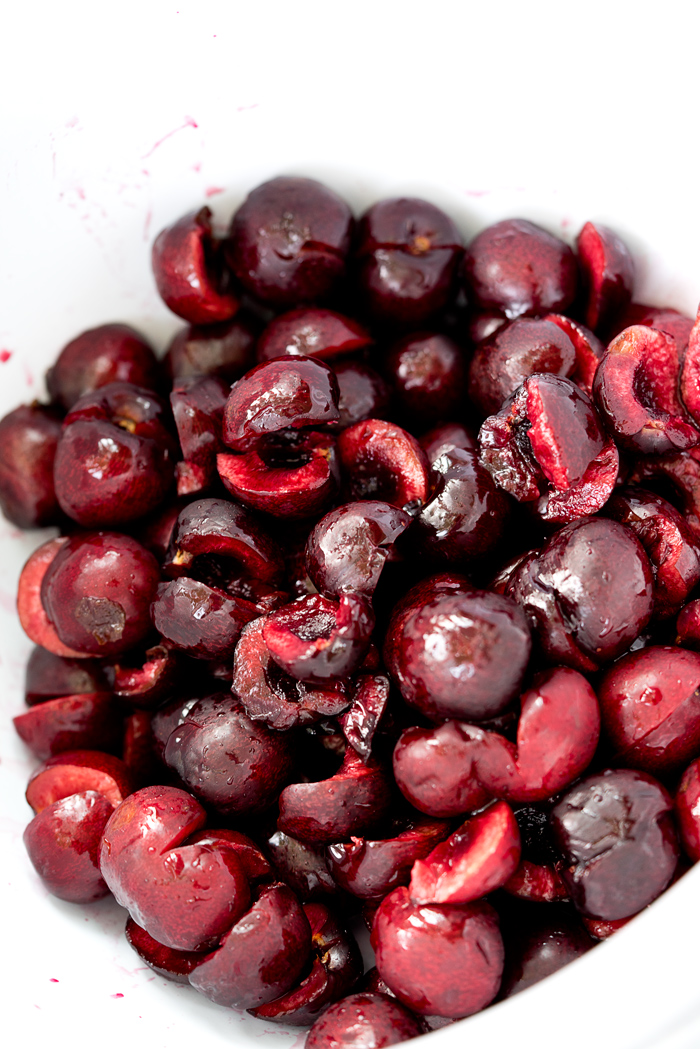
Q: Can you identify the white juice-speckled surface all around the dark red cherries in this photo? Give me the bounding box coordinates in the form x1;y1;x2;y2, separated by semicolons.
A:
0;0;700;1049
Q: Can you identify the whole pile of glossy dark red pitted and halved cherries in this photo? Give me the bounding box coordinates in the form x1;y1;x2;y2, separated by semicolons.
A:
0;177;700;1049
